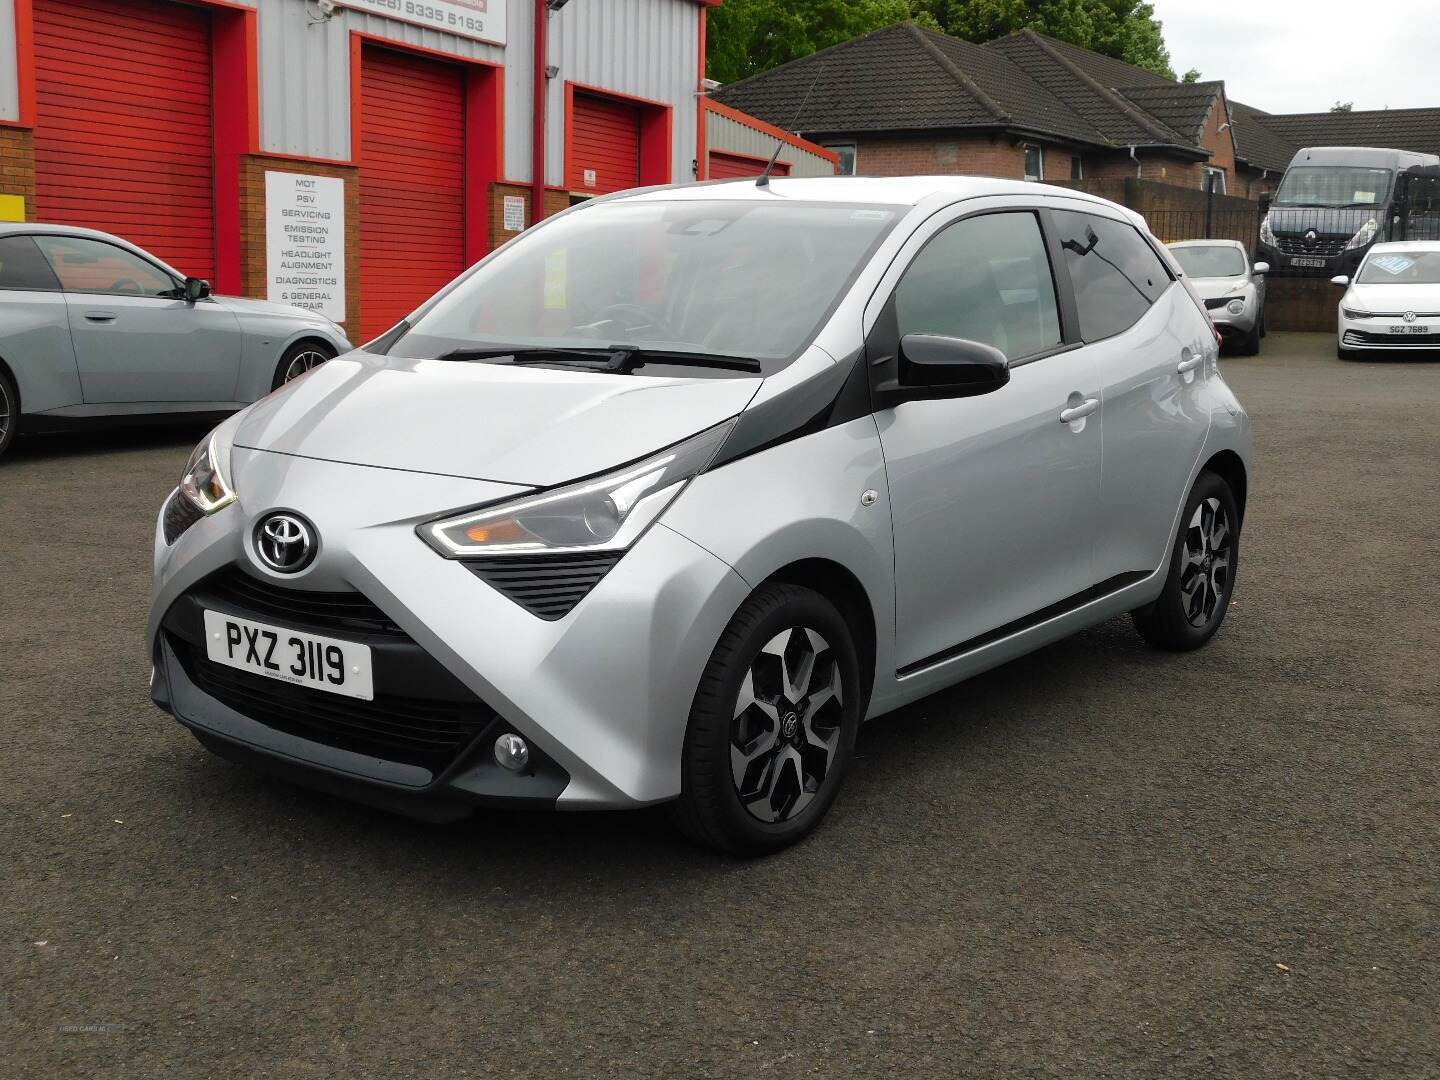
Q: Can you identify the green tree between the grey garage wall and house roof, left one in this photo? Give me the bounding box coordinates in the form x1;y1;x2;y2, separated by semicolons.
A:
706;0;943;82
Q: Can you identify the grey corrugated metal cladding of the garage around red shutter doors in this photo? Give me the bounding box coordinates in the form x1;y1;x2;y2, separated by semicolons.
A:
0;0;700;184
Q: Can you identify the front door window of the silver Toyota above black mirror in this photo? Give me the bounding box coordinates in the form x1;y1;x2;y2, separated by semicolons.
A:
896;213;1060;360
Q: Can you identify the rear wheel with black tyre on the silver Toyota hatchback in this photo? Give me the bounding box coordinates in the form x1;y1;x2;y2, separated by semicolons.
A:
1130;472;1240;649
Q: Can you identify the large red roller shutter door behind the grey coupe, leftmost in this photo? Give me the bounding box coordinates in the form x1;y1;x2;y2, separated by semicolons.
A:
33;0;215;279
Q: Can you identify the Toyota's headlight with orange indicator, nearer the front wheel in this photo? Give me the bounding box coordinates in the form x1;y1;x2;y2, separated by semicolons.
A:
418;420;734;559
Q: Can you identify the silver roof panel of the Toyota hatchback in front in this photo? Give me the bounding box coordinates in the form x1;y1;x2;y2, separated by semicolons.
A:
596;176;1138;220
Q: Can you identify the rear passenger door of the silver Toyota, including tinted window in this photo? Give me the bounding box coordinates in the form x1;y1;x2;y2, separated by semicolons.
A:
1053;210;1217;580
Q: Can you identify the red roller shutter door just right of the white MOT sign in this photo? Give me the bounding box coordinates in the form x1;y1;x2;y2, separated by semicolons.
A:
360;46;465;338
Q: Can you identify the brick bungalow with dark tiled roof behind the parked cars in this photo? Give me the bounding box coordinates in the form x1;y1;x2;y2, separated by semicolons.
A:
713;23;1440;197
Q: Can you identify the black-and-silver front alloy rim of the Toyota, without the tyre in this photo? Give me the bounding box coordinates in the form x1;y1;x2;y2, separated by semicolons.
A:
730;626;844;824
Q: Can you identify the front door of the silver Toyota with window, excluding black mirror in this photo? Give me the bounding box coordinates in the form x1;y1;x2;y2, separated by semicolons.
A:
867;209;1103;672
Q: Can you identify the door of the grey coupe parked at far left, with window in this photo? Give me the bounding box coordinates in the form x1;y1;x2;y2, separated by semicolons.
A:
36;235;243;405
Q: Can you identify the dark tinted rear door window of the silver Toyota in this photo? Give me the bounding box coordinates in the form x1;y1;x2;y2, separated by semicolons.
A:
1054;210;1171;341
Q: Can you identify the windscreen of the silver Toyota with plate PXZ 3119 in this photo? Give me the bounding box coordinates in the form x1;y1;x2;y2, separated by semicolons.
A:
392;200;900;373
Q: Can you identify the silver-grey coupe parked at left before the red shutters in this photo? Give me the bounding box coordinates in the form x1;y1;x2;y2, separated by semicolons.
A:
0;223;350;454
